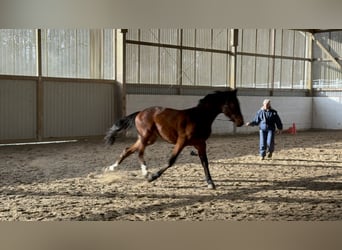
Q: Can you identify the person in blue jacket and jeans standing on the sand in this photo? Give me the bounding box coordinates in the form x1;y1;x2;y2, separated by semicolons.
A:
246;99;283;160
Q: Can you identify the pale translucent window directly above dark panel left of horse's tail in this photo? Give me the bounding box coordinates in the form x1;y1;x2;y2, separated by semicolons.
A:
42;29;115;79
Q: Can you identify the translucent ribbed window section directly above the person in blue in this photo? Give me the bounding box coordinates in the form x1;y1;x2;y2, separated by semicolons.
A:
237;29;306;89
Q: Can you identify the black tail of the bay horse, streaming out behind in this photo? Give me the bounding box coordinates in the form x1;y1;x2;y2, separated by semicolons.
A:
104;111;140;145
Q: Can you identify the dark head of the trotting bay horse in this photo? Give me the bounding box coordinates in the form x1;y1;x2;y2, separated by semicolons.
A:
222;89;244;127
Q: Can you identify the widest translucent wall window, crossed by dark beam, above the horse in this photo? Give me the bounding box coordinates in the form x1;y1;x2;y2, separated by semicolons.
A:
126;29;229;86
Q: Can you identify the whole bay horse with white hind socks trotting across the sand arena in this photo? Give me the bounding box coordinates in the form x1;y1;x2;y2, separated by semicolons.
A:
105;90;244;189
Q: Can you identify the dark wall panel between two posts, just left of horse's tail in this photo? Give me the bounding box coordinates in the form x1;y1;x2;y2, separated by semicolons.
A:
44;81;115;138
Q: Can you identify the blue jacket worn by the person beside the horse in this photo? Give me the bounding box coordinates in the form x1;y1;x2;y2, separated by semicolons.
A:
250;109;283;131
